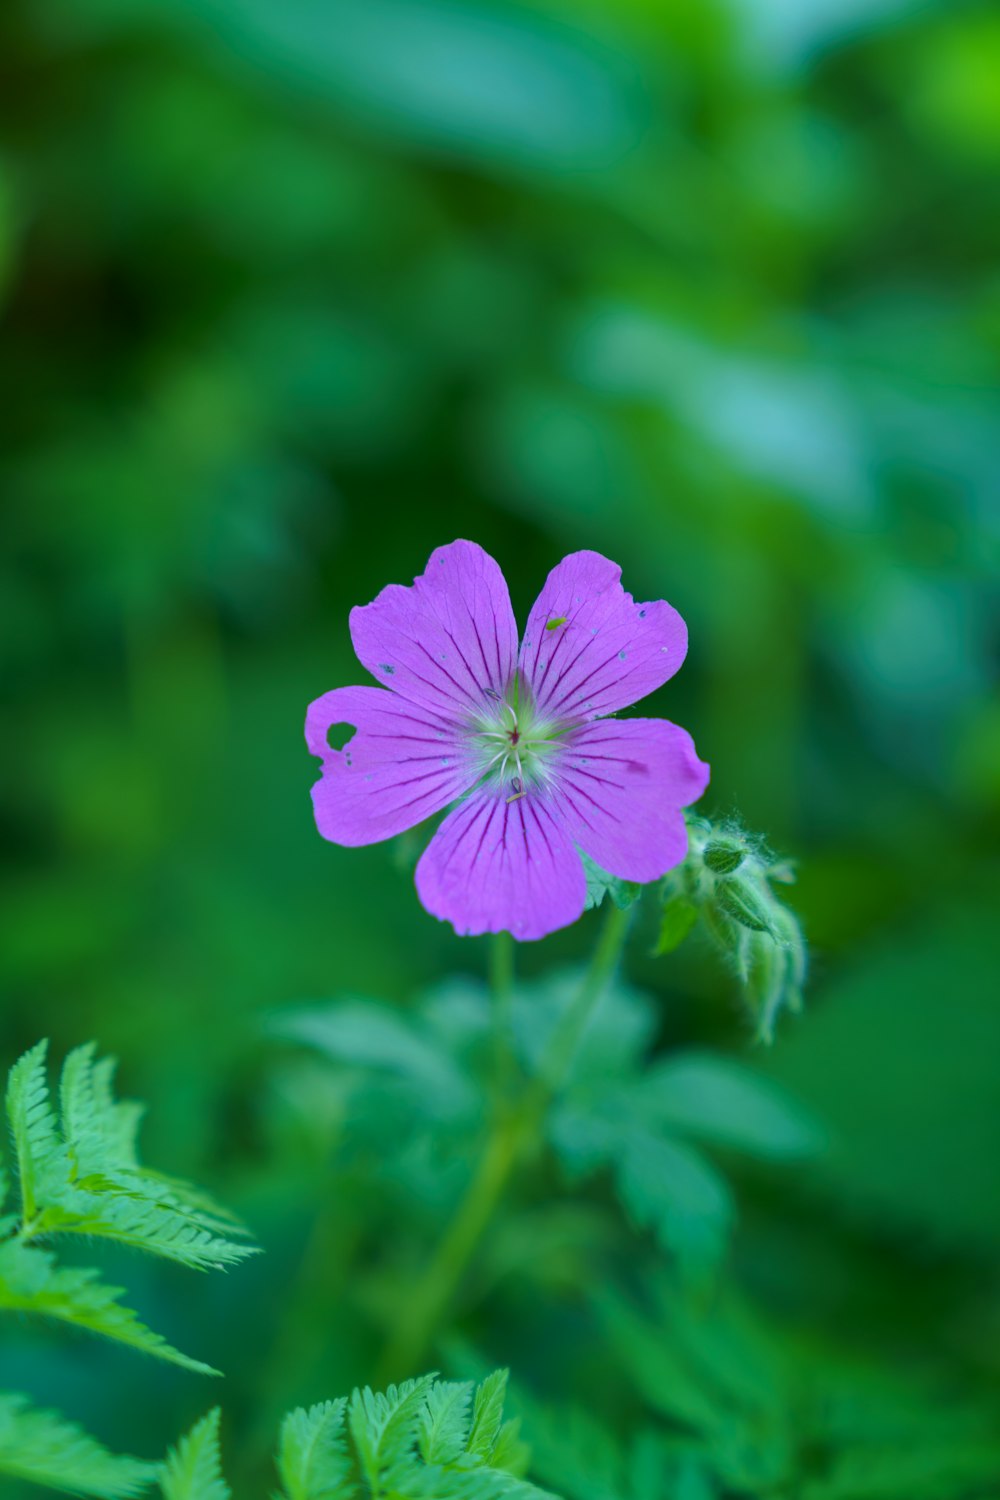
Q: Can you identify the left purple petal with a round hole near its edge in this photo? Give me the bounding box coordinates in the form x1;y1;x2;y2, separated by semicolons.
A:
306;687;477;848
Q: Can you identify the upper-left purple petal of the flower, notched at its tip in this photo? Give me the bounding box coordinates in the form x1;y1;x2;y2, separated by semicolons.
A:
351;542;517;723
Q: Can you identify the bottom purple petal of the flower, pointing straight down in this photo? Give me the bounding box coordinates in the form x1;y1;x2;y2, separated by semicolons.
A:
417;789;586;942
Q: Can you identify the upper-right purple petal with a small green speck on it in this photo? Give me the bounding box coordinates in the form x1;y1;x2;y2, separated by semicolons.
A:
520;552;688;719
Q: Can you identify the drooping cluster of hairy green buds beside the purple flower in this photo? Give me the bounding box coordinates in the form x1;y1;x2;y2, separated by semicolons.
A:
657;813;807;1043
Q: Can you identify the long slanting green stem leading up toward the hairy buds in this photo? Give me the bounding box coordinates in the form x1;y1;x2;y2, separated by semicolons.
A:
378;906;628;1385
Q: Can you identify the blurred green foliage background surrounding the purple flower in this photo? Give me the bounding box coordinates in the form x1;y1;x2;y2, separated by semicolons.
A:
0;0;1000;1493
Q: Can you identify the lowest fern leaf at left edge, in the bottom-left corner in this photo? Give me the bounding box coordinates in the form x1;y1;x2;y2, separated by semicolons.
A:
0;1392;156;1500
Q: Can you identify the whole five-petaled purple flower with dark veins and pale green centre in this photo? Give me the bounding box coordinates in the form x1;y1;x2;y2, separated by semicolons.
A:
306;542;709;941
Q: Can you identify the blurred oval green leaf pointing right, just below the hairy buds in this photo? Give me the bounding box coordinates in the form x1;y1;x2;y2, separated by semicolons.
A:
636;1053;825;1161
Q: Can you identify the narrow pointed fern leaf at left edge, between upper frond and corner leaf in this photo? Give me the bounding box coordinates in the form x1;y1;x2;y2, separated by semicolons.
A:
0;1241;219;1376
